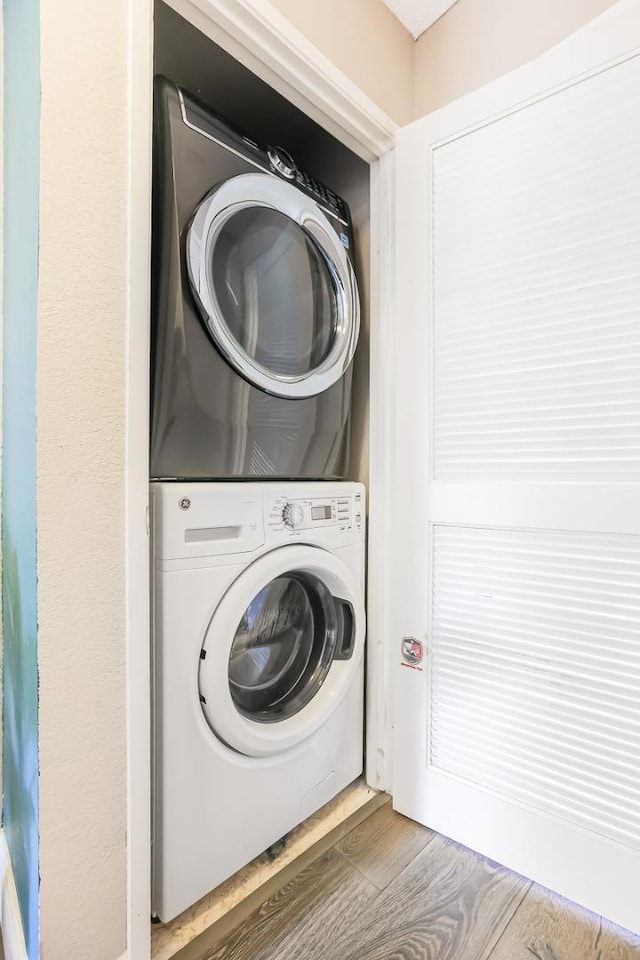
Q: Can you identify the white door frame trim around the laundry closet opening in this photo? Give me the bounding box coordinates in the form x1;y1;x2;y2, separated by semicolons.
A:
125;0;397;960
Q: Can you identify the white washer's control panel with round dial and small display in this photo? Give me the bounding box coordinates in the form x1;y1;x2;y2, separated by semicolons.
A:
266;493;364;533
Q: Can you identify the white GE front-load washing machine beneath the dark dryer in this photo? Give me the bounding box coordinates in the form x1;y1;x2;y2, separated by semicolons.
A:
151;481;365;922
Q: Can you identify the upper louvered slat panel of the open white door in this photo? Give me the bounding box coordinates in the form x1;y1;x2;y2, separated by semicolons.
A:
433;59;640;482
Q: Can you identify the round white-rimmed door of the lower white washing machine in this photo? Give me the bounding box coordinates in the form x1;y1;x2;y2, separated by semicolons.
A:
199;545;364;756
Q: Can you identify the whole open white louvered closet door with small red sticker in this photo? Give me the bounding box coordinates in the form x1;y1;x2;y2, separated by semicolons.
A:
393;0;640;932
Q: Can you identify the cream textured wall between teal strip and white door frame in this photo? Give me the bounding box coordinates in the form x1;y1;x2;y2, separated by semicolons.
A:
37;0;129;960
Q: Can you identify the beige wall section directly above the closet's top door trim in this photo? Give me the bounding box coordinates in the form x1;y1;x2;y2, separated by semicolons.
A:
271;0;413;123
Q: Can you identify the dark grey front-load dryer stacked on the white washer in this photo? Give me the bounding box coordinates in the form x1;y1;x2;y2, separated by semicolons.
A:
151;77;360;479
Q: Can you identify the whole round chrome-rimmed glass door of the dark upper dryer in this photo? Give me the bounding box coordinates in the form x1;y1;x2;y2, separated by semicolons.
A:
187;174;360;399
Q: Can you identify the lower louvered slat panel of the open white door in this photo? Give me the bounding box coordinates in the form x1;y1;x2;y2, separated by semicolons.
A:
429;525;640;845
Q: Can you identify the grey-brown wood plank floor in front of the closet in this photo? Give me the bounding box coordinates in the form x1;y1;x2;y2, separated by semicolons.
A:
182;804;640;960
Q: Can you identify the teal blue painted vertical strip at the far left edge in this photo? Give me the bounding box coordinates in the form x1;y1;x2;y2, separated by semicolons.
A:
2;0;40;960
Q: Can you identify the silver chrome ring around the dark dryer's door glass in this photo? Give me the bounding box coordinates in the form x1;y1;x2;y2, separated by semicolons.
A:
186;173;360;399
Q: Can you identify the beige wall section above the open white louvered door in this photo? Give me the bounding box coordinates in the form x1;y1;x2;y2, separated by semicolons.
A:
414;0;614;117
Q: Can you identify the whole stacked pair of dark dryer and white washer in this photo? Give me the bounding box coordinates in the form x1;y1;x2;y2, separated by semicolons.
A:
151;78;365;922
